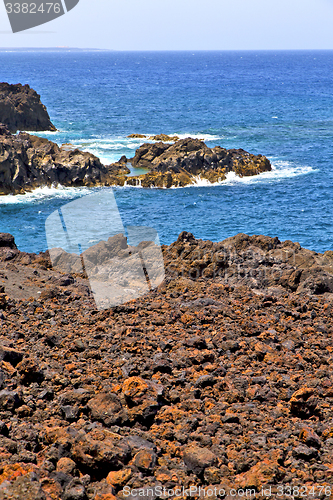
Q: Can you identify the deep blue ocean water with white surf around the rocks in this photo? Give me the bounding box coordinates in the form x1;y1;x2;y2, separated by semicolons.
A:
0;50;333;252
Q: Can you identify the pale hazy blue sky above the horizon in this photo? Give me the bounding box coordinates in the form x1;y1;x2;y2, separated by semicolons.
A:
0;0;333;50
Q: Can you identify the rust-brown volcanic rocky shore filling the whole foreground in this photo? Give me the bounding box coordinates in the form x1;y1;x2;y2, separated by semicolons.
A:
0;233;333;500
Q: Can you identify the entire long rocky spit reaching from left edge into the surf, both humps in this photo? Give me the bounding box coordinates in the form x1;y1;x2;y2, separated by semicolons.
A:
0;130;271;194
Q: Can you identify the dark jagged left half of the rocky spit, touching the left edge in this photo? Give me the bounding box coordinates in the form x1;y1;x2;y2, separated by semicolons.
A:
0;125;129;194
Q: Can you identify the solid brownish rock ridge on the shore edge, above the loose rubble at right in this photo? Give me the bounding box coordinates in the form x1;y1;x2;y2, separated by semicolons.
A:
164;231;333;294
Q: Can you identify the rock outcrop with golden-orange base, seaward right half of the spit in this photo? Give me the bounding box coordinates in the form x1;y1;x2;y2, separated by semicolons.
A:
127;138;271;187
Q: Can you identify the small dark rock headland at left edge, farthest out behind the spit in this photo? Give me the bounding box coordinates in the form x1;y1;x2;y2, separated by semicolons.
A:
0;82;56;132
